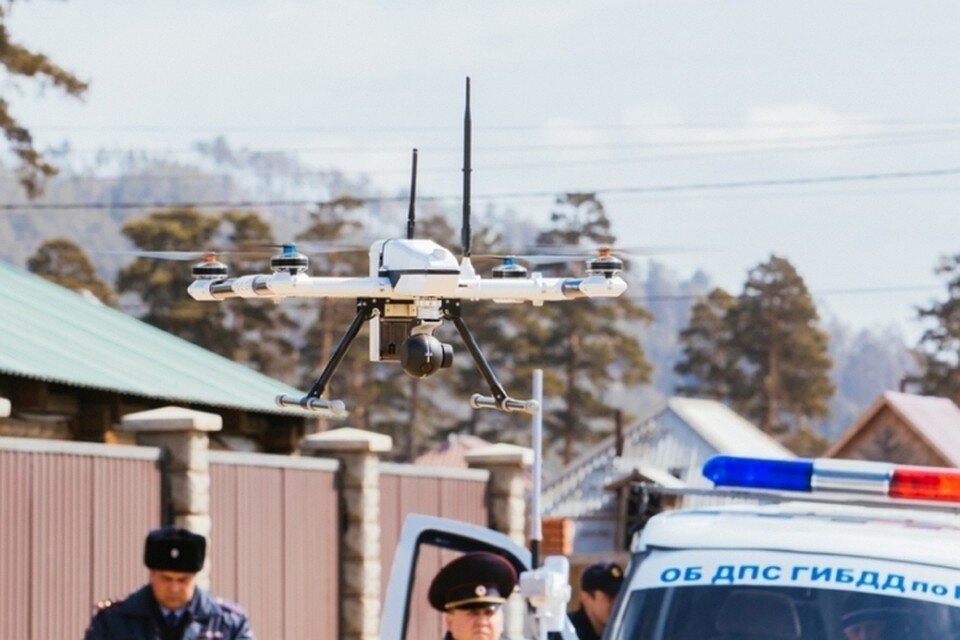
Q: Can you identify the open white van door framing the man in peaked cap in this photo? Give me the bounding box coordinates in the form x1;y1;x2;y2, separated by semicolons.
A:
380;514;577;640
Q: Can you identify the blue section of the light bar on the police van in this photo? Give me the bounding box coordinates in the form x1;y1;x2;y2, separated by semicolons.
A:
703;456;813;492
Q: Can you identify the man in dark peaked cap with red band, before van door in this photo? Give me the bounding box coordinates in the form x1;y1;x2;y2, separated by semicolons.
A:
427;551;517;640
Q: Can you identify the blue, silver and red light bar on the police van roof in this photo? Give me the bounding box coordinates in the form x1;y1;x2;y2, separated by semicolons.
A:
703;456;960;502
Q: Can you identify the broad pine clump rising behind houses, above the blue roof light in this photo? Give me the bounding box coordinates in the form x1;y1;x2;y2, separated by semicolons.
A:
676;256;834;440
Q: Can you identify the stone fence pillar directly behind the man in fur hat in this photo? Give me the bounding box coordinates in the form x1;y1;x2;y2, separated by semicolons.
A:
120;407;223;589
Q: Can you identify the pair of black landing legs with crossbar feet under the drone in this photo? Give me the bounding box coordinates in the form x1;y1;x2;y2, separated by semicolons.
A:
276;298;540;417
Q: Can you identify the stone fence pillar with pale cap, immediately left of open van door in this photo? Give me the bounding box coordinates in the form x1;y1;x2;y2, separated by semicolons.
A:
300;427;393;640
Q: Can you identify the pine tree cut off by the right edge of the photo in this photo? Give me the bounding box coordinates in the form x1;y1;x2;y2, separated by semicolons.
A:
917;254;960;403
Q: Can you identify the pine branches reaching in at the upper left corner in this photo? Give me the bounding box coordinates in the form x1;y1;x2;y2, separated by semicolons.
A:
0;7;87;198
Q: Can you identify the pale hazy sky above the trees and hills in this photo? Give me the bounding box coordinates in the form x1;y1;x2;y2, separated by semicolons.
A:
8;0;960;340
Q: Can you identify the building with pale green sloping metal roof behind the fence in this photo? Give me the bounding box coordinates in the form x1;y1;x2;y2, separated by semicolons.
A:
0;262;317;453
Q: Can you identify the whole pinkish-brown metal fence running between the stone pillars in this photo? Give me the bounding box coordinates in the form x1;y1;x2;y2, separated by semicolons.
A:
0;430;489;640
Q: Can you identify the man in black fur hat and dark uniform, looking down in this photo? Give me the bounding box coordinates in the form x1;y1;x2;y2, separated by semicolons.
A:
84;527;253;640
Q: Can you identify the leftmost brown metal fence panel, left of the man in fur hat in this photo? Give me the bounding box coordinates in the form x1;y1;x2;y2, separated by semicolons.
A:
0;438;161;640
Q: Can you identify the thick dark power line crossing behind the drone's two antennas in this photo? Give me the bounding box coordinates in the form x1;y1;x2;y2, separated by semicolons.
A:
7;168;960;211
